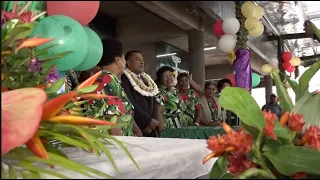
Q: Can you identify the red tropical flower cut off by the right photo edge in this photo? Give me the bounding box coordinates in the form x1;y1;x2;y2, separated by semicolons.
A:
302;126;320;150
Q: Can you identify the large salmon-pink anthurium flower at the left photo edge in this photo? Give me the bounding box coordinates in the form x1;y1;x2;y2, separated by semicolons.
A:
1;88;47;155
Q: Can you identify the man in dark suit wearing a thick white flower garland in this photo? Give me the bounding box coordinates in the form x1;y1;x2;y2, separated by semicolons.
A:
121;50;163;137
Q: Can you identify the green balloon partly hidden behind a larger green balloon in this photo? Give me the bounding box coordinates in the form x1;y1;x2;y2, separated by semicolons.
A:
73;27;103;71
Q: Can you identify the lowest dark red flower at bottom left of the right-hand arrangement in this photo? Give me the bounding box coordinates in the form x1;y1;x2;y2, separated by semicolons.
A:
227;155;257;176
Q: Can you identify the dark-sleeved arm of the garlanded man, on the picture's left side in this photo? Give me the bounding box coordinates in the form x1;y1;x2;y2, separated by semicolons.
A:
121;75;152;126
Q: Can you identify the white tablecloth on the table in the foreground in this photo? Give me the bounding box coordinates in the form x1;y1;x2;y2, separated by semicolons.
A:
46;137;216;179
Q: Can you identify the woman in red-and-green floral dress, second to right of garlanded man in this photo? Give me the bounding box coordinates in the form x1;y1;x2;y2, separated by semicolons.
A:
177;73;202;126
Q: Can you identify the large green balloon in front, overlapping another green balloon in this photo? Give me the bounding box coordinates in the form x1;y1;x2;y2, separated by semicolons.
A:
31;15;88;71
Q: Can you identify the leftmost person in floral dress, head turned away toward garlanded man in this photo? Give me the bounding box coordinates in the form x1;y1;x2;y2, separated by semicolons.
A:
84;39;141;136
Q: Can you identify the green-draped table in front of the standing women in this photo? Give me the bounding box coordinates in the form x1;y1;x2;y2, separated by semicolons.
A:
160;126;238;139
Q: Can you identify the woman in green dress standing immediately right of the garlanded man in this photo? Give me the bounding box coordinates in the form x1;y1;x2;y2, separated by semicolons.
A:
156;66;188;128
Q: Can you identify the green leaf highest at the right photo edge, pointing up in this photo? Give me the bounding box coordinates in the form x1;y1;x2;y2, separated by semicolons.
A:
299;61;320;95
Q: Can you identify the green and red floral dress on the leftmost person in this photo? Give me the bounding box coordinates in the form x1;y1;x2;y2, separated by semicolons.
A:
85;70;134;136
